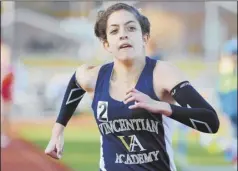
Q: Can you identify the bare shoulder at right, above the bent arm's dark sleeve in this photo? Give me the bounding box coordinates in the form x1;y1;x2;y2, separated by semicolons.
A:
154;61;188;91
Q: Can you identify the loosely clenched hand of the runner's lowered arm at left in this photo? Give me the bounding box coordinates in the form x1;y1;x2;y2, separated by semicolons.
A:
45;133;64;159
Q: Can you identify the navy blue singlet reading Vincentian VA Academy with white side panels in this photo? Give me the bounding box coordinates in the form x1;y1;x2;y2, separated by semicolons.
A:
92;57;176;171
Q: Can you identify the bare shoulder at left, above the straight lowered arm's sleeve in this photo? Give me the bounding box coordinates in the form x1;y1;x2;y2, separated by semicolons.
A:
76;64;101;92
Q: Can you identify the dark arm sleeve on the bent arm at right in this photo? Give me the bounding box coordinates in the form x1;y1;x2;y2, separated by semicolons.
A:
165;82;220;133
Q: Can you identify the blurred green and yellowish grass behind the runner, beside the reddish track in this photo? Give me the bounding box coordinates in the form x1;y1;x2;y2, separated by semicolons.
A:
16;120;227;171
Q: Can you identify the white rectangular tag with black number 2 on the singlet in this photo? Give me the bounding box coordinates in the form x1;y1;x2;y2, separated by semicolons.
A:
97;101;108;122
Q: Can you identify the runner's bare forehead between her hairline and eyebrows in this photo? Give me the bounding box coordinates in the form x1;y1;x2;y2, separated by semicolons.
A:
107;10;138;26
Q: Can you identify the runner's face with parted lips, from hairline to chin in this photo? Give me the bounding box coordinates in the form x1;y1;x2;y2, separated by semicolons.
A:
104;10;147;60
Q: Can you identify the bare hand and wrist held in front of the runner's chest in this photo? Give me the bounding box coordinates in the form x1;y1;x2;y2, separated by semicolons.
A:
124;88;172;116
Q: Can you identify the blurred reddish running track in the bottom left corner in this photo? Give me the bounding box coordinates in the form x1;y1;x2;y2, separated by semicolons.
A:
1;138;71;171
